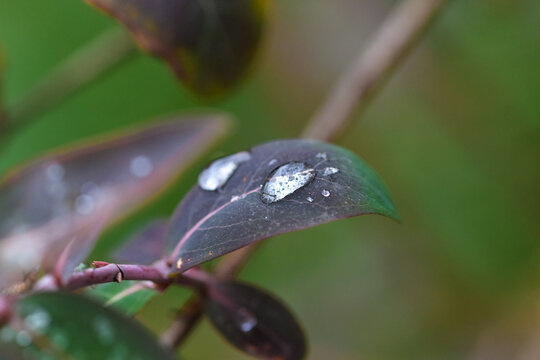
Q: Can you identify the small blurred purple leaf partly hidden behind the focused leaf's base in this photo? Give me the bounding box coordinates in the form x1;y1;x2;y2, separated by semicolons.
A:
113;219;169;265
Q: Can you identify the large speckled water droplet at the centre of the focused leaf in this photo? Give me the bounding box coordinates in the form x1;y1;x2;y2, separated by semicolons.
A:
261;161;315;204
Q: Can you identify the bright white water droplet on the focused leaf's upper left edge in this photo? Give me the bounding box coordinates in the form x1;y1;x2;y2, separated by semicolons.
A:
199;151;251;191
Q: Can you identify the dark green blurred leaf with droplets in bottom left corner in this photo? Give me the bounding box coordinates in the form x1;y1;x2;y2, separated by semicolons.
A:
0;292;174;360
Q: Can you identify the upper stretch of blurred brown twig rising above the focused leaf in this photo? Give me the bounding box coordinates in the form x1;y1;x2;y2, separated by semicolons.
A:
303;0;446;141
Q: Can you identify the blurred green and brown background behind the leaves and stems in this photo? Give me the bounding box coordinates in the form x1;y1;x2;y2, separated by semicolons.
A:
0;0;540;360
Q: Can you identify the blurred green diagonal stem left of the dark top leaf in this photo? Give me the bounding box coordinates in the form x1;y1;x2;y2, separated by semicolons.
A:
4;27;136;131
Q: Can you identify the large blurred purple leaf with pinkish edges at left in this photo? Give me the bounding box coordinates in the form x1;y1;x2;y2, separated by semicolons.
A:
0;115;228;289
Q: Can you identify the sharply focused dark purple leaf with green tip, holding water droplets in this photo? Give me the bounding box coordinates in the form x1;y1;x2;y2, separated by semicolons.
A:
167;140;398;271
